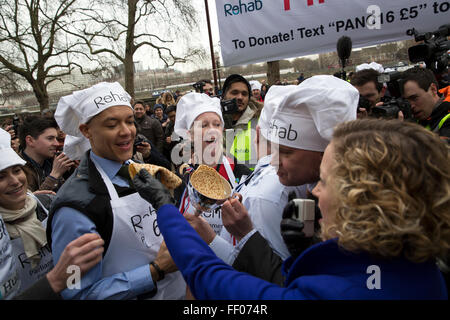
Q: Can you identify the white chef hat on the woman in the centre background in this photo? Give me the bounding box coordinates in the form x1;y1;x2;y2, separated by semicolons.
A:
174;92;224;137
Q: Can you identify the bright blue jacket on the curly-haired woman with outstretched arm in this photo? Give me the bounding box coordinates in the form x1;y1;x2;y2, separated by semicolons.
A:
158;205;448;300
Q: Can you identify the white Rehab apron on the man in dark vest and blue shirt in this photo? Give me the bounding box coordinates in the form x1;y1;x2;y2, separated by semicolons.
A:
91;159;186;300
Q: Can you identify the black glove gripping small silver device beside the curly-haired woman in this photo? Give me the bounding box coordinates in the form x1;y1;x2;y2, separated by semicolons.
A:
280;191;314;259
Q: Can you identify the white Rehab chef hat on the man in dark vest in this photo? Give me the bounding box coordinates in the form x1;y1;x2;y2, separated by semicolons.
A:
55;82;133;137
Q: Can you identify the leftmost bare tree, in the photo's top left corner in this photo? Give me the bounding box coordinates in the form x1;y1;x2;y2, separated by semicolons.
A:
0;0;102;110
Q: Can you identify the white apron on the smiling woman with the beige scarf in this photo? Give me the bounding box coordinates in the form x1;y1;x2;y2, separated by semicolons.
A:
11;193;53;293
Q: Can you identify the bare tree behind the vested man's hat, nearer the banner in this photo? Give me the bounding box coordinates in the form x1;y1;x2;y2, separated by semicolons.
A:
69;0;203;96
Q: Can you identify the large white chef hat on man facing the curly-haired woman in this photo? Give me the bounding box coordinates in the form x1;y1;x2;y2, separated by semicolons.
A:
269;75;359;152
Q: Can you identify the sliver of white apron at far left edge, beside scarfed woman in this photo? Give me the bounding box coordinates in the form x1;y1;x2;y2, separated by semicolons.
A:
0;216;20;300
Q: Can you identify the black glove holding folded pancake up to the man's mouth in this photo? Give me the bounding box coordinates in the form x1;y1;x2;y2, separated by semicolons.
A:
133;169;175;211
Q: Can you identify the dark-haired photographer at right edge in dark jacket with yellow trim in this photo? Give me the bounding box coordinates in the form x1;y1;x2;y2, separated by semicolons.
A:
402;68;450;139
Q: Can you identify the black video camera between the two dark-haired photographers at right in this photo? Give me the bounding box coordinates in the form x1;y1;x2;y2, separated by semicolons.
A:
372;71;412;120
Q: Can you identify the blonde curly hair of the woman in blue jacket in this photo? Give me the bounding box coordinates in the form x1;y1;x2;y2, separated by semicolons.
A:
322;119;450;262
